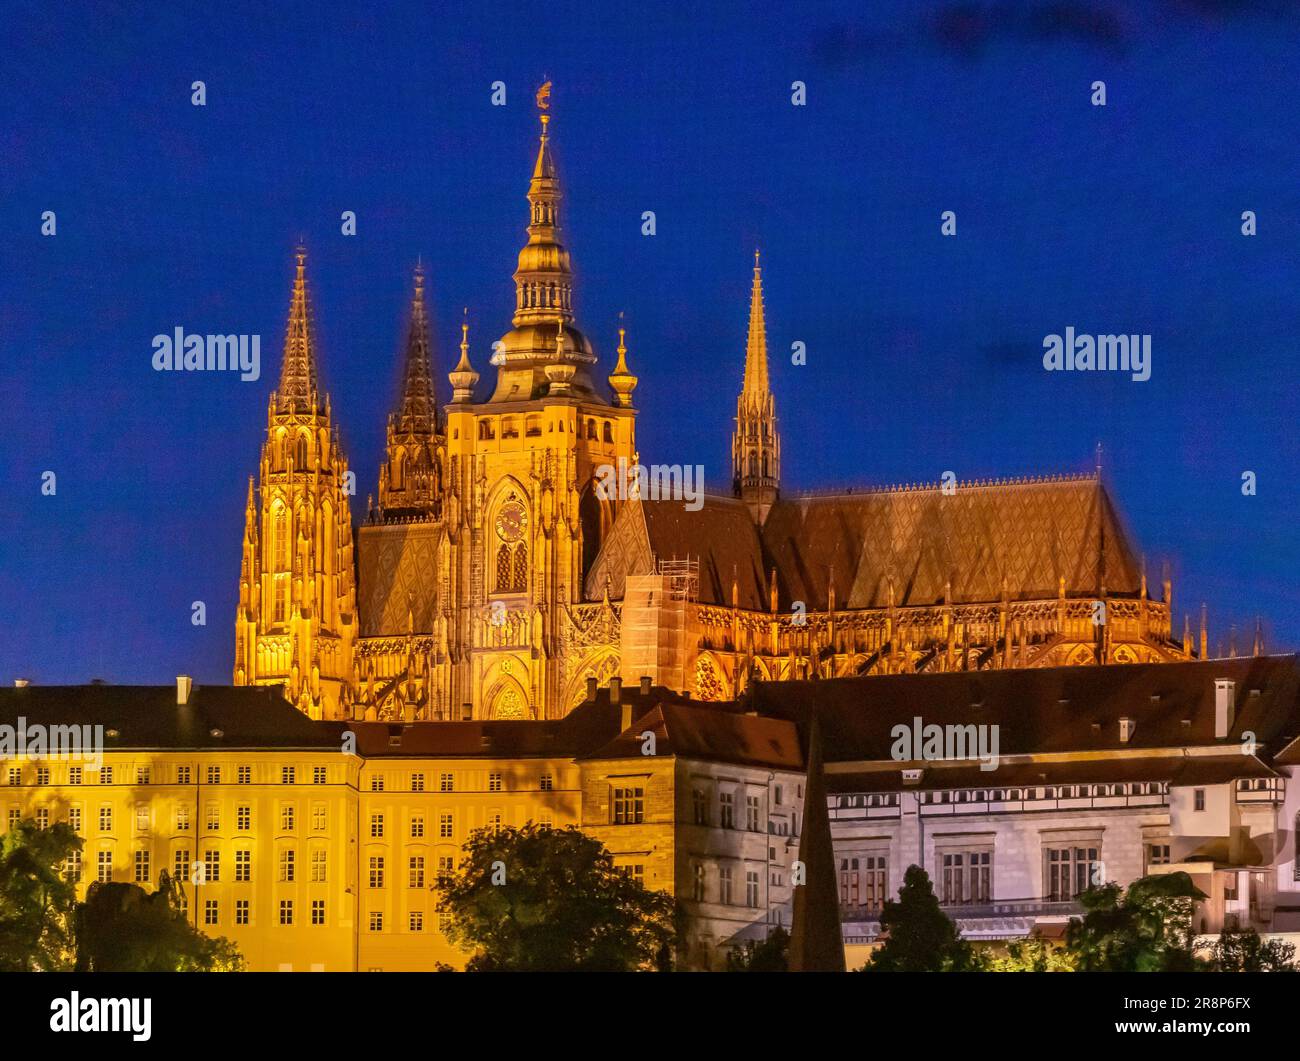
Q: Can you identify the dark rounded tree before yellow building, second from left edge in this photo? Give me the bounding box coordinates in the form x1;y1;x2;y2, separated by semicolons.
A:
75;872;244;973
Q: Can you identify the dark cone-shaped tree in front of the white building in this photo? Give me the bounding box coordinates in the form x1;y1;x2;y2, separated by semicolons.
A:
863;866;979;973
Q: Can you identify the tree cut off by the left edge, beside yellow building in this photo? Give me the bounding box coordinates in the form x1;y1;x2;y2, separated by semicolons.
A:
0;818;82;973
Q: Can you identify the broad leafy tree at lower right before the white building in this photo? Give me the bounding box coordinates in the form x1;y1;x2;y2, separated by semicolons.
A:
1066;872;1205;973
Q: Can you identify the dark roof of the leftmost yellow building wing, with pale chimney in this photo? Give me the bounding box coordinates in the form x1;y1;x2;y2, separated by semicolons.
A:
0;685;339;752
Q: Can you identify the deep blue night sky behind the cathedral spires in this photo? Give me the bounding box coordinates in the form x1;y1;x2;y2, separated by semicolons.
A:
0;0;1300;683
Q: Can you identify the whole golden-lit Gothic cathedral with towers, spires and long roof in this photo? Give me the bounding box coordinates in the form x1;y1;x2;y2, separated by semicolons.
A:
234;94;1201;722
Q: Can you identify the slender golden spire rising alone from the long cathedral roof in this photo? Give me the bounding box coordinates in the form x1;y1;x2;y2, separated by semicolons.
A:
732;251;781;523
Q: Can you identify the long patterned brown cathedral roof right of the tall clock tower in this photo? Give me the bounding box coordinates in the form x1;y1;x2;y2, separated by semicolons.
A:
586;476;1141;611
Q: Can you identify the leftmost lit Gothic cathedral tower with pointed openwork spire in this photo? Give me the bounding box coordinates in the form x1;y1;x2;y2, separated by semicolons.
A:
234;247;356;719
